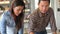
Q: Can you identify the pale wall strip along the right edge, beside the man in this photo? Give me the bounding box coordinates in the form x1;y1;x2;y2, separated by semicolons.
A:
54;0;60;29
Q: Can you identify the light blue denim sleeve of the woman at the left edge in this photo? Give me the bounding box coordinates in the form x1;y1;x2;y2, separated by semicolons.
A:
0;14;6;34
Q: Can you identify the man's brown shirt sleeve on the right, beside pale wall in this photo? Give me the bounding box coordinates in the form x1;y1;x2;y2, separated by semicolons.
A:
50;9;57;32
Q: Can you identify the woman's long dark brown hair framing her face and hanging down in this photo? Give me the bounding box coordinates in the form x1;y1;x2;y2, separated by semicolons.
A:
9;0;25;28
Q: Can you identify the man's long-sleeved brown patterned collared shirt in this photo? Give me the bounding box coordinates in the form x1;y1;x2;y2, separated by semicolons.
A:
29;8;57;32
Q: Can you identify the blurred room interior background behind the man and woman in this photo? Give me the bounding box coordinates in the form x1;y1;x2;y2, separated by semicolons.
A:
0;0;60;34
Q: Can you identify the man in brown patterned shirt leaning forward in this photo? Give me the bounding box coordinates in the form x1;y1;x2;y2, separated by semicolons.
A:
29;0;57;34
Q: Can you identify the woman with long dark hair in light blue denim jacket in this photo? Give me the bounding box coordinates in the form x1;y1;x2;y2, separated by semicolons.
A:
0;0;25;34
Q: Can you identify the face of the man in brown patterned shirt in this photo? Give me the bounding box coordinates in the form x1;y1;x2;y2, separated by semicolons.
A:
38;1;49;13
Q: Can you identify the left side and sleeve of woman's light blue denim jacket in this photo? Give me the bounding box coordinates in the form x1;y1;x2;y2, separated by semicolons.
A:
0;11;15;34
